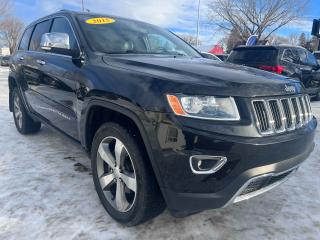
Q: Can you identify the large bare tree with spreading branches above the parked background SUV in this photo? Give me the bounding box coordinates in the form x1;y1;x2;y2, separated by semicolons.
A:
208;0;309;41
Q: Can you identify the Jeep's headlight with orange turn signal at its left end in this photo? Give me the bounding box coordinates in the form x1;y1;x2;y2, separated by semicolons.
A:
167;95;240;121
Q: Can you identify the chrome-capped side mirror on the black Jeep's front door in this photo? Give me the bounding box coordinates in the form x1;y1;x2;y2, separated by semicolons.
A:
40;32;80;58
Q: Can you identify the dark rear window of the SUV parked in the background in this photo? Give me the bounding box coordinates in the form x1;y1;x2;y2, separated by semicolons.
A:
228;48;278;65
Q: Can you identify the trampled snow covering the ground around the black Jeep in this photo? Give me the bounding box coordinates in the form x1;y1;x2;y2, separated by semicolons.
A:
0;65;320;240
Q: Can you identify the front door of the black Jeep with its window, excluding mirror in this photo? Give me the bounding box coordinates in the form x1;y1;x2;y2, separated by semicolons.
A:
26;17;81;140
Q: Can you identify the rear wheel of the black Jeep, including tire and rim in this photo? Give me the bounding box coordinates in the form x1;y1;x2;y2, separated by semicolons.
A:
12;88;41;134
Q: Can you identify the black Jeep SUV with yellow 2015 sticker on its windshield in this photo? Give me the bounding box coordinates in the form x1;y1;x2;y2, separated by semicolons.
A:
9;11;317;225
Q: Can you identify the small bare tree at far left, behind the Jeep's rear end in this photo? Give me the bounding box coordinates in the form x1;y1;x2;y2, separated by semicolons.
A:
0;16;24;53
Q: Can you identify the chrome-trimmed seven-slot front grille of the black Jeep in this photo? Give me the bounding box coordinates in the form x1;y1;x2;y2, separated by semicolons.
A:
252;95;312;135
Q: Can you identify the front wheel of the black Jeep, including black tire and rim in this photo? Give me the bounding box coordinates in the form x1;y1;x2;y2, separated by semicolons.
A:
91;123;165;226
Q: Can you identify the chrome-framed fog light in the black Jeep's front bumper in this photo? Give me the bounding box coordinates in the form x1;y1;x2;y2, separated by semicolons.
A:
189;155;227;174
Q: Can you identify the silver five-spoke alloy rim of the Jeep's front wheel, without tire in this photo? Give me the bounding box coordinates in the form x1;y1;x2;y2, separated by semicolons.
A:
97;137;137;212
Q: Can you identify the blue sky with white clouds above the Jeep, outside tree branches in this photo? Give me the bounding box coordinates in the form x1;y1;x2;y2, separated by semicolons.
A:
13;0;320;45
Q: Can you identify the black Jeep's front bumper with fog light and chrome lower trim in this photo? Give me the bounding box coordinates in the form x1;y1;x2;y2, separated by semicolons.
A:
149;118;317;216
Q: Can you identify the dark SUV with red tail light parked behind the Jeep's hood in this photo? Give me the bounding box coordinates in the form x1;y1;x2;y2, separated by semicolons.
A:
227;45;320;100
